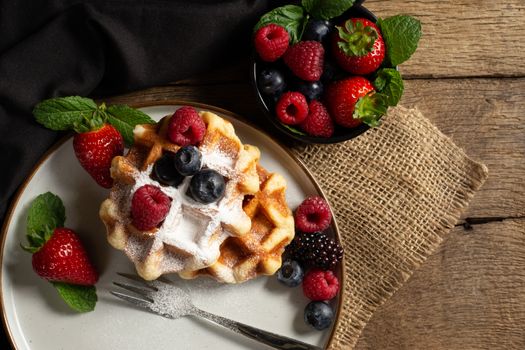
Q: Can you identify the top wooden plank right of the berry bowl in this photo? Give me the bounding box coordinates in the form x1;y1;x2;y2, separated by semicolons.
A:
365;0;525;77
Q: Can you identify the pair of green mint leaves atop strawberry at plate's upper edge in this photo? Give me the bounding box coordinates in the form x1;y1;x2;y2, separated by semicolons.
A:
33;96;155;147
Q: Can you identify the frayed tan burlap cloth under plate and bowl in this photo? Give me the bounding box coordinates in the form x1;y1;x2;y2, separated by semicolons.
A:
293;107;488;349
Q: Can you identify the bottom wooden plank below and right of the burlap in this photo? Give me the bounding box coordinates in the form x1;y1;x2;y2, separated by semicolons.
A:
356;219;525;350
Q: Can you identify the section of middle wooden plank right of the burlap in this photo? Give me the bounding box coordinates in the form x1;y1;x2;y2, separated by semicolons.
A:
401;79;525;217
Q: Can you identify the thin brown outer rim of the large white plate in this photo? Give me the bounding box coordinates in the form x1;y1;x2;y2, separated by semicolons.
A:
0;99;346;349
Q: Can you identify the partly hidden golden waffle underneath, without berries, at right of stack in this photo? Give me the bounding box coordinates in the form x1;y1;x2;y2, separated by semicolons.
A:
179;165;295;283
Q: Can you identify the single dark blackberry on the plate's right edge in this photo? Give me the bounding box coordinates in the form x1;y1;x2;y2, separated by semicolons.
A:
286;232;343;270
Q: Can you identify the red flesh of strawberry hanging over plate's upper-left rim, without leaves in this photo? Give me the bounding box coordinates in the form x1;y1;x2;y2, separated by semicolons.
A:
73;124;124;188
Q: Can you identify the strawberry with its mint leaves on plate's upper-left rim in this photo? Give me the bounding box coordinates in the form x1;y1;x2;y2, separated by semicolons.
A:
33;96;154;188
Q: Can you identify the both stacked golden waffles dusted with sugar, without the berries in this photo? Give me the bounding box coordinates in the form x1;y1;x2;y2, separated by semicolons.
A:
100;111;294;283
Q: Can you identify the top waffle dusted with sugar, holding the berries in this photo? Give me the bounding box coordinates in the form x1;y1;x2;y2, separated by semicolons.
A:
100;112;260;280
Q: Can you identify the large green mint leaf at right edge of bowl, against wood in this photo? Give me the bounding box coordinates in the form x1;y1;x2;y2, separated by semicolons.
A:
377;15;421;67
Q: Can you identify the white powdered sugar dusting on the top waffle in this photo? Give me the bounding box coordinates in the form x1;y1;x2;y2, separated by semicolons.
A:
115;149;246;272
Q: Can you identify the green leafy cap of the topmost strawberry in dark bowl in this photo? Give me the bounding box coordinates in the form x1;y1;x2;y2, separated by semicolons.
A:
336;19;378;56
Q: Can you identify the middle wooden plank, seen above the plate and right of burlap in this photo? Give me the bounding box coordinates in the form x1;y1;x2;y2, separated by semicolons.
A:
103;79;525;218
